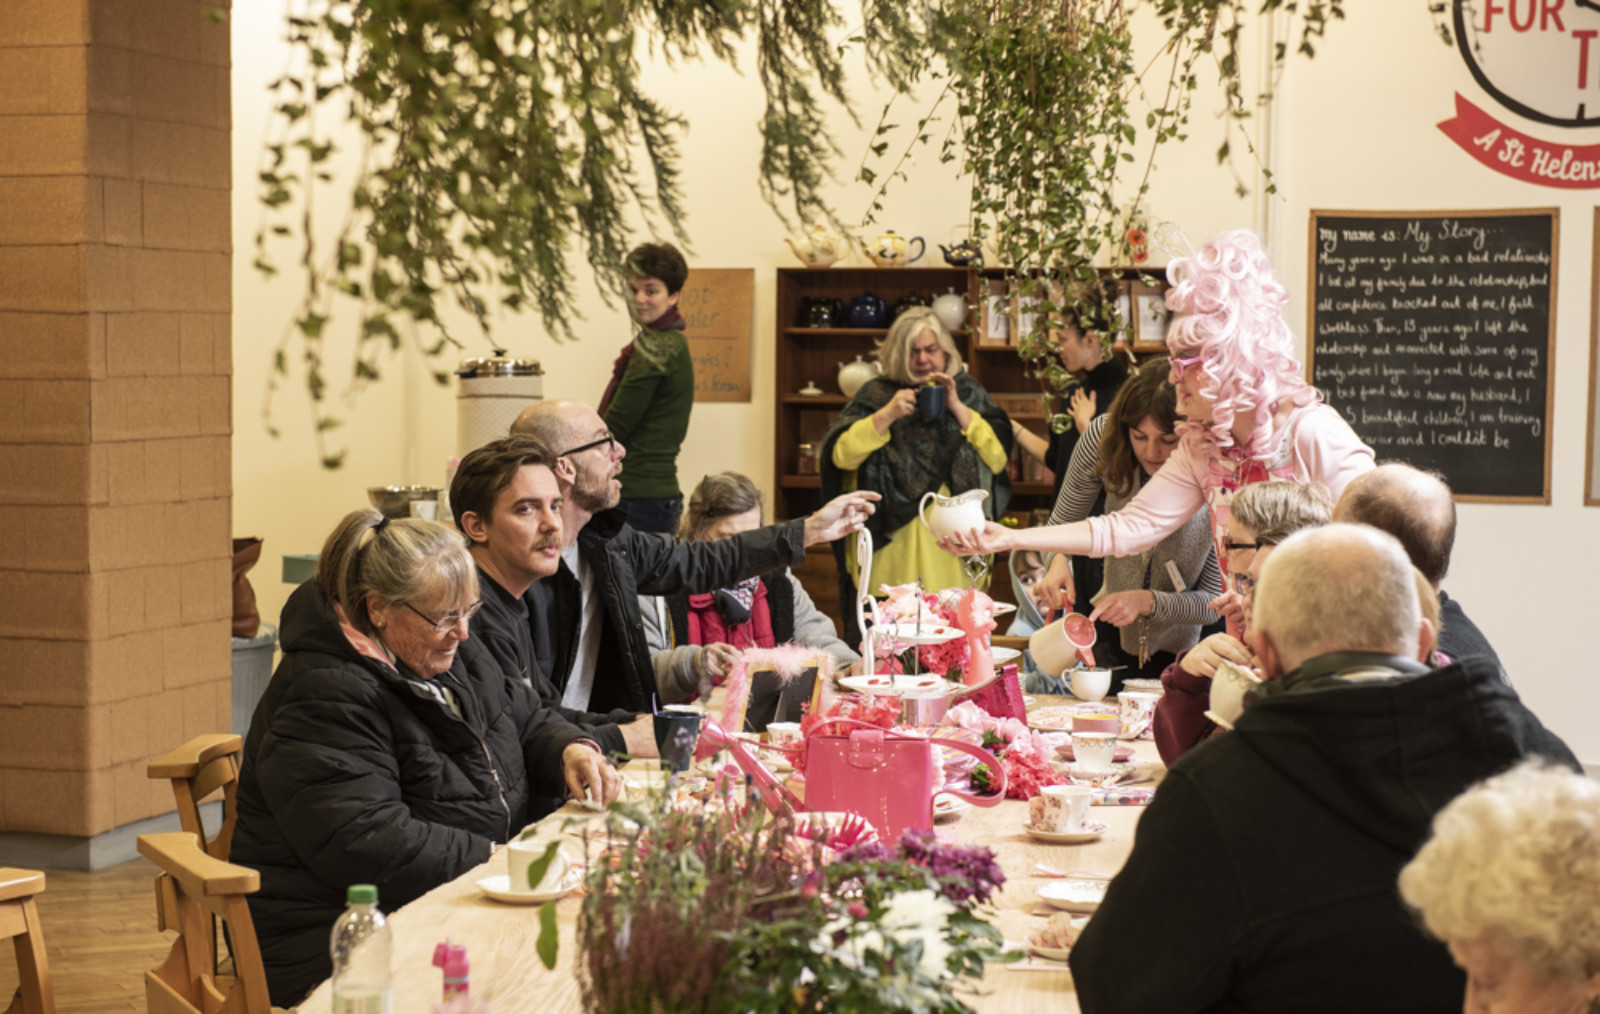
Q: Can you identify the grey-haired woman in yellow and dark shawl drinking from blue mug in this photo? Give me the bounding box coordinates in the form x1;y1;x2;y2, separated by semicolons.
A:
821;307;1011;641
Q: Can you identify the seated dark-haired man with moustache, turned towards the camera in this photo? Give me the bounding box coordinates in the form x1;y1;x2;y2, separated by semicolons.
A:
450;437;656;757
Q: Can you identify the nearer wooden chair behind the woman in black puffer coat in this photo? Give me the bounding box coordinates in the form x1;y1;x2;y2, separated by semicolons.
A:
139;832;272;1014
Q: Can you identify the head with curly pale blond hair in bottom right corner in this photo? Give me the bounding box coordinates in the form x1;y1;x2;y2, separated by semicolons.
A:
1400;764;1600;1014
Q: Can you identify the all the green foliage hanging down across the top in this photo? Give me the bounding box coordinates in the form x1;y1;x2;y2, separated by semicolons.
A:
256;0;1342;467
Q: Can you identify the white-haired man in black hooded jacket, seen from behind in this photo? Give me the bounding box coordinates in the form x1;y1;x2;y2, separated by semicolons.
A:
1070;525;1579;1014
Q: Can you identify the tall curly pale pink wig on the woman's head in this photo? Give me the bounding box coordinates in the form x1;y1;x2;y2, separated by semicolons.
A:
1166;229;1317;457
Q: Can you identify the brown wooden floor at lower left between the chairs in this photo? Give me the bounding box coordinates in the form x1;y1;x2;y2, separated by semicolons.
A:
0;859;171;1014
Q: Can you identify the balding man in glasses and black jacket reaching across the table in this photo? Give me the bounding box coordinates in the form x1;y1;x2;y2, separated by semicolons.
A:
512;401;878;712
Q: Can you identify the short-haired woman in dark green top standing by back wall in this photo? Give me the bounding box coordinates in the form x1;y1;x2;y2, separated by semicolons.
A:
600;243;694;534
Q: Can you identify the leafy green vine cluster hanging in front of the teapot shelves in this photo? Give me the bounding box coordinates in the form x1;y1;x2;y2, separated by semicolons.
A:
858;0;1344;427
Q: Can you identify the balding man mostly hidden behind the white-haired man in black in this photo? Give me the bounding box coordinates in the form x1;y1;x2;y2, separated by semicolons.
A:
1333;462;1510;671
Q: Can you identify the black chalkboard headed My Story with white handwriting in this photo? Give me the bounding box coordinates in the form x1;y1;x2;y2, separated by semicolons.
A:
1307;208;1560;504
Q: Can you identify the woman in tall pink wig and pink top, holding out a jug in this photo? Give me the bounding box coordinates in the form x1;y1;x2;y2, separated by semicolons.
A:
939;230;1373;623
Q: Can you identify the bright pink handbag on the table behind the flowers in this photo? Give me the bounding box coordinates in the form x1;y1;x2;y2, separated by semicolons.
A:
805;718;1005;844
